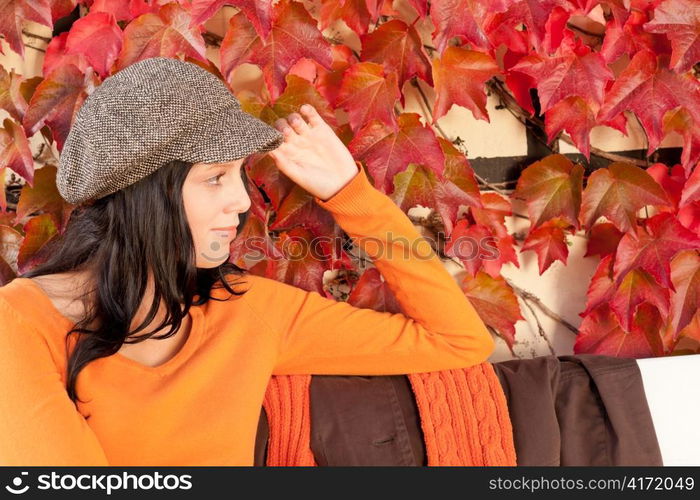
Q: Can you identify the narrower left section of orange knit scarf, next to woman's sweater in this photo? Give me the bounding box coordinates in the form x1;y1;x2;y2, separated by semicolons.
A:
263;375;317;466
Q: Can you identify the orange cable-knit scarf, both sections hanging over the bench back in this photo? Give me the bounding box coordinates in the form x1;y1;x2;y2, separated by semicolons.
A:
263;362;516;466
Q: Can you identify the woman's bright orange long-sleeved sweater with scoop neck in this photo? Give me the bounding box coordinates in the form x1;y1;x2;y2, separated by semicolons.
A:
0;162;494;466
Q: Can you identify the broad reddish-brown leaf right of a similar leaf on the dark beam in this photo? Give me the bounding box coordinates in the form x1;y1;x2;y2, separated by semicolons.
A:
581;162;670;232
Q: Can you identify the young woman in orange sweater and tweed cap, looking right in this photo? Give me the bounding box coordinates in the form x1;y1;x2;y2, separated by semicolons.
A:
0;58;494;466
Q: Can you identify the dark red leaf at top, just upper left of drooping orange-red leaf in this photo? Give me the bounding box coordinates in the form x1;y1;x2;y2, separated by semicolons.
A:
360;19;433;98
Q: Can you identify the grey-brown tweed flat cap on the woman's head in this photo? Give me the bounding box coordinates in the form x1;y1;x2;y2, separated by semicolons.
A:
56;57;284;204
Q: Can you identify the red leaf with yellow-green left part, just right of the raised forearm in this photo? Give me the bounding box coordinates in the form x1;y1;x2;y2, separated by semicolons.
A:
391;163;480;236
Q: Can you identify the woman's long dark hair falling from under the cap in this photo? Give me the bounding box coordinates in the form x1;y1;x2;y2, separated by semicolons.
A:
21;160;253;403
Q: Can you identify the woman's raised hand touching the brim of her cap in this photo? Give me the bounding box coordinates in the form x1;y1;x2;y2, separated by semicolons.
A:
268;104;359;201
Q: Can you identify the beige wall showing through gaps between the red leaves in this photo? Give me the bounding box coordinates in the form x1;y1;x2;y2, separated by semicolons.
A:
0;0;681;362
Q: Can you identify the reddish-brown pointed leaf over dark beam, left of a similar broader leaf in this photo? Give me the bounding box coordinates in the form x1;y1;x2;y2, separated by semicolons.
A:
513;154;583;229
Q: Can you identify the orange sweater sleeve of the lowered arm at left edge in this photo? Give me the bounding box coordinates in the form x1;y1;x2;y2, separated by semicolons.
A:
0;298;109;466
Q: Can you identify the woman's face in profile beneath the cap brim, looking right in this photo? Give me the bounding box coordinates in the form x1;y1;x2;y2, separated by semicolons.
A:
182;158;250;268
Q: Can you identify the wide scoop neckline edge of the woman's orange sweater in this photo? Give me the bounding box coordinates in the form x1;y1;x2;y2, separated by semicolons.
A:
13;278;204;374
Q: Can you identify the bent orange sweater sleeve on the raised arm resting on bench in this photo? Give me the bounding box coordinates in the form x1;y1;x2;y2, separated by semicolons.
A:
244;163;494;375
